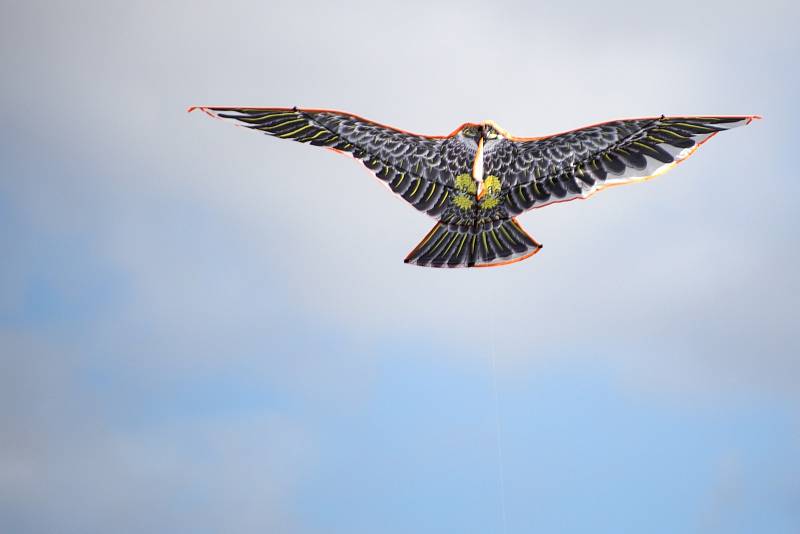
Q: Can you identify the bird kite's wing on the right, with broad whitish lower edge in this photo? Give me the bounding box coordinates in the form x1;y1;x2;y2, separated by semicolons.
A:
484;115;758;216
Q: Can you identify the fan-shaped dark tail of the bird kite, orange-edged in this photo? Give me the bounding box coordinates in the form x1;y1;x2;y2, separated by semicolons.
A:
405;219;542;267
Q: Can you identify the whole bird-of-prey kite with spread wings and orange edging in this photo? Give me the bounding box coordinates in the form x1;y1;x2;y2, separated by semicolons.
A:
189;107;759;267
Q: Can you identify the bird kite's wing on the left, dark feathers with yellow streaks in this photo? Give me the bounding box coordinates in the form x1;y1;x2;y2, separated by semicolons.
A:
189;107;475;216
